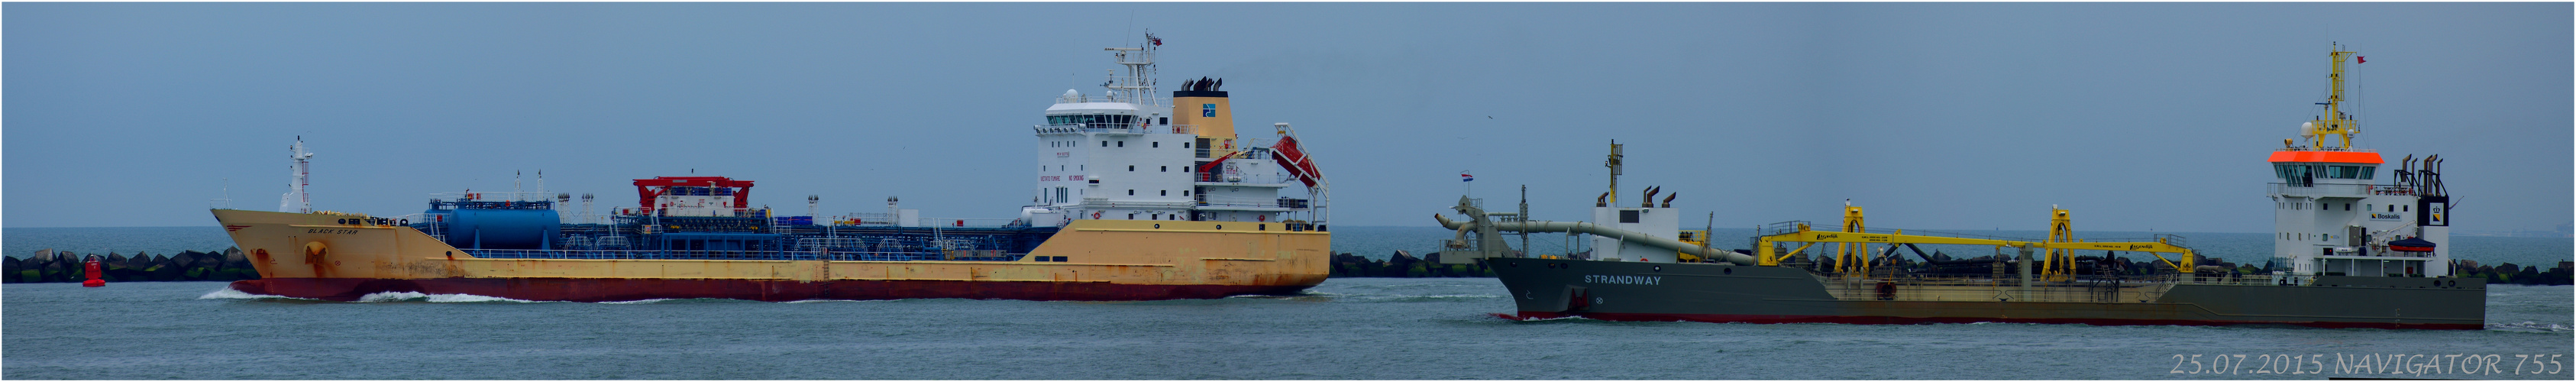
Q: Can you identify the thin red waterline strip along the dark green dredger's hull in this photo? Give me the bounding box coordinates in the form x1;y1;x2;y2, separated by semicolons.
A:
1494;312;2486;330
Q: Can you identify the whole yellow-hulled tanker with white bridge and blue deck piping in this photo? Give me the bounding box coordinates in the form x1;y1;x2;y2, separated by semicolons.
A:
214;34;1332;302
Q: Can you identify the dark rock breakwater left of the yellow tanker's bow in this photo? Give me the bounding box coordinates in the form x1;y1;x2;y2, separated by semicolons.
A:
0;248;260;284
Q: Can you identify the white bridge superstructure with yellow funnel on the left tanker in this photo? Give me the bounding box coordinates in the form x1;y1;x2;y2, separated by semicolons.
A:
1020;34;1329;230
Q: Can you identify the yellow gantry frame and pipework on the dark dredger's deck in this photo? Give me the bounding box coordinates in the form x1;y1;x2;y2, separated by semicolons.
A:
1754;206;2197;274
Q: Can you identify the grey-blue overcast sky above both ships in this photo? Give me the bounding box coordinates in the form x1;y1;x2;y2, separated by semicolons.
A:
0;2;2576;232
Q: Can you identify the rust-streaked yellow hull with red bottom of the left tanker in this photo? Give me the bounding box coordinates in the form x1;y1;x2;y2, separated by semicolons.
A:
214;209;1332;302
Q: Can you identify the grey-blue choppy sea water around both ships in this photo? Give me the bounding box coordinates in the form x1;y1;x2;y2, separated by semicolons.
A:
0;227;2576;380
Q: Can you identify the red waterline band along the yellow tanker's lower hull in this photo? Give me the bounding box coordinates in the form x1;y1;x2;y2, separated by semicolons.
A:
232;279;1306;302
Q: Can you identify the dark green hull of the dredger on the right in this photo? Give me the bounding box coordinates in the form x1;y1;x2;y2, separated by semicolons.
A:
1484;258;2486;330
